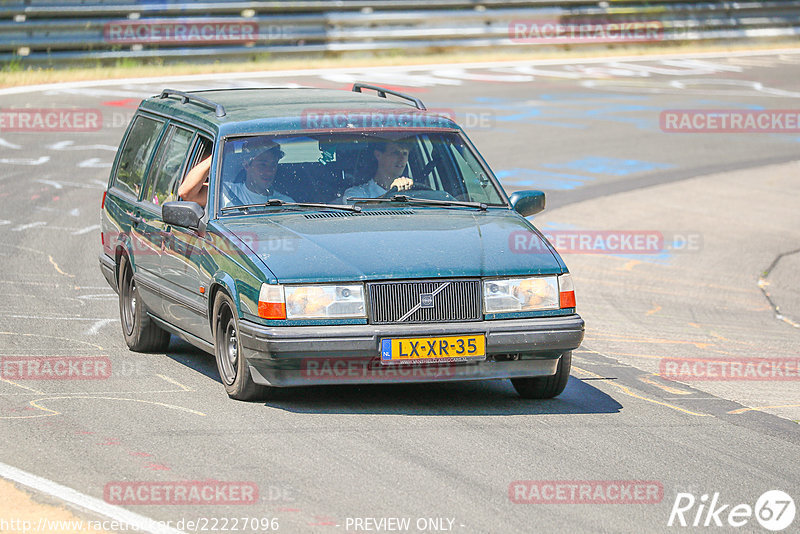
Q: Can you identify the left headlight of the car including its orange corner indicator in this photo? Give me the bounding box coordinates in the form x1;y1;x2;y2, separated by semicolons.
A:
259;284;367;319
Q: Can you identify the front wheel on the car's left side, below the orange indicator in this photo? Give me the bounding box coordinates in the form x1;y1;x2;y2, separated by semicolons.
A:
213;291;275;401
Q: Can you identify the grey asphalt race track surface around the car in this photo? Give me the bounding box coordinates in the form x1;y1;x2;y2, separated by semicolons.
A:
0;51;800;533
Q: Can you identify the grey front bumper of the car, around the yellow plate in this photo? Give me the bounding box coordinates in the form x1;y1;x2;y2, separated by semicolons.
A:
239;314;584;387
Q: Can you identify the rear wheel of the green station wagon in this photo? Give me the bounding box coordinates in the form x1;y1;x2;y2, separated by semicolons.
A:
119;256;169;352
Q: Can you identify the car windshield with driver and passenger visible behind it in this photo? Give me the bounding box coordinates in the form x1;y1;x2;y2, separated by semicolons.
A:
219;131;506;212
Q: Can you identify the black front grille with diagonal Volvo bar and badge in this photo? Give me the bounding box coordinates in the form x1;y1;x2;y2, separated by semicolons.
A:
367;280;481;324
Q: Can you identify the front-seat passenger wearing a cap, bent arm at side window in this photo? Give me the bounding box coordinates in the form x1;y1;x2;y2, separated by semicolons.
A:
178;137;294;207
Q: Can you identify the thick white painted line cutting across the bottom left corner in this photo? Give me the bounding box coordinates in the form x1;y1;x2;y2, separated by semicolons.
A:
0;463;183;534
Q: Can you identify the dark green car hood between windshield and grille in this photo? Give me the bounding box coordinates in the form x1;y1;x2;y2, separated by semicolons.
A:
216;207;562;283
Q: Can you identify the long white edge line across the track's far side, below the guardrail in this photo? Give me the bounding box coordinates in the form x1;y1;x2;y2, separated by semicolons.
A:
0;48;800;95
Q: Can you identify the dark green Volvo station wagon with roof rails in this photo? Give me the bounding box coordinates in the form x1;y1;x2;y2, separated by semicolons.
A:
100;84;584;400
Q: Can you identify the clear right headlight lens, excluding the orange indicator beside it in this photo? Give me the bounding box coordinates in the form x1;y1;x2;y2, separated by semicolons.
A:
483;276;559;313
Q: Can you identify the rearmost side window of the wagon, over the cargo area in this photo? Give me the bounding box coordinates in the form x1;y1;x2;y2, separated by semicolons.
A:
114;116;164;198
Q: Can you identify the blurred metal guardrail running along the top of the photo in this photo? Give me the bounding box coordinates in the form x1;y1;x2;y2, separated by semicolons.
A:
0;0;800;64
